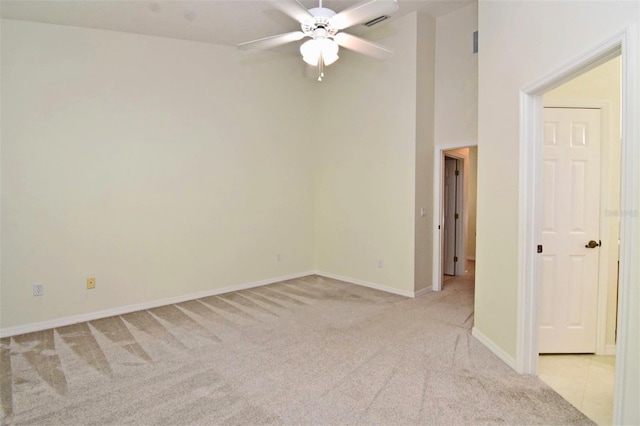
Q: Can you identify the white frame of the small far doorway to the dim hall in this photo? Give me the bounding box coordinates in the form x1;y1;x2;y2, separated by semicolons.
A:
431;141;478;291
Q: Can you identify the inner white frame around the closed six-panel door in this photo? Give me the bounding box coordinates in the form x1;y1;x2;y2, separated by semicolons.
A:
543;99;618;355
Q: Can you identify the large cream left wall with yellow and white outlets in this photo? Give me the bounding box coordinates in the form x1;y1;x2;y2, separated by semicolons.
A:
0;20;317;329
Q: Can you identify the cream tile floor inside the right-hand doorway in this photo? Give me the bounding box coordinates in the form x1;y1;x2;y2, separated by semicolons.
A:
538;354;616;425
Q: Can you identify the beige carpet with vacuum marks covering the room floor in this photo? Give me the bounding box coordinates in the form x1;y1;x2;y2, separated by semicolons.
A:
0;276;591;425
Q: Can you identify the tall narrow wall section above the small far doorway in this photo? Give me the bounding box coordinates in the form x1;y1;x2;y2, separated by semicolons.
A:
434;3;478;145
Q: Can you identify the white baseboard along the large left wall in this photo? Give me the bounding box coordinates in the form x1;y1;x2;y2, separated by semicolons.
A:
0;272;313;337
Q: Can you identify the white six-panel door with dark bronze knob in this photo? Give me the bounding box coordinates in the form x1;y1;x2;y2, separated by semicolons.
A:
539;108;601;353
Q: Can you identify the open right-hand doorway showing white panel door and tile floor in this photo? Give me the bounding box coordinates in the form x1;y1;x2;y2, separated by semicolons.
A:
539;57;621;424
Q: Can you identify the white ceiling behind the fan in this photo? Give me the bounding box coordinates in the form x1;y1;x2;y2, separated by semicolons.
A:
0;0;476;46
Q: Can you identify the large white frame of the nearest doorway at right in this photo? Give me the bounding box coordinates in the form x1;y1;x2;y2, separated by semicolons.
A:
516;25;640;424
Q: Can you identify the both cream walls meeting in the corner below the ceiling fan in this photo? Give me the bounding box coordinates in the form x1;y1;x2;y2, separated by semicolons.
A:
1;13;435;330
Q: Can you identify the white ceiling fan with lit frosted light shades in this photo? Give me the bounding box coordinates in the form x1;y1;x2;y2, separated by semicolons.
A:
238;0;398;81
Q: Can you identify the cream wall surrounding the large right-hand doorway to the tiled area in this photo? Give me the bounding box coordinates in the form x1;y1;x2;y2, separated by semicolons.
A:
475;1;640;424
